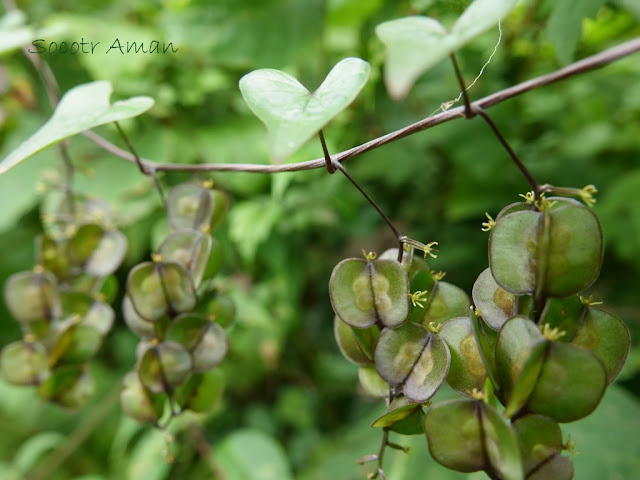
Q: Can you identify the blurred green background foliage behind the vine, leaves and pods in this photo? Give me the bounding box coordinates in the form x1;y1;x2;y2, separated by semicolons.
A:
0;0;640;480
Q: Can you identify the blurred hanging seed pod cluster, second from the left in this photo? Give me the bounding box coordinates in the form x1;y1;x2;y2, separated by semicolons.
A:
121;183;235;425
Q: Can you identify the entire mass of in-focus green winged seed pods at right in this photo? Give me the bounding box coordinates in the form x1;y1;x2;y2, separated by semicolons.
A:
330;191;630;480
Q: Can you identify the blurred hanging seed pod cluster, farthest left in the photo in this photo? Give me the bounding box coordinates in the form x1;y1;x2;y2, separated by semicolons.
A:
0;192;127;408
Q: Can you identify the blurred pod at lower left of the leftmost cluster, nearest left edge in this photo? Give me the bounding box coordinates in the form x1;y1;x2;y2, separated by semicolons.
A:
0;341;49;385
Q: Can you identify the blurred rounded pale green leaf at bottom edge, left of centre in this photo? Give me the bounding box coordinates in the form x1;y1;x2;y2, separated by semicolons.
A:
214;429;293;480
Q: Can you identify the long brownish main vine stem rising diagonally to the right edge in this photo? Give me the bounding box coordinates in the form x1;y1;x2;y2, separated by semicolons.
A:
69;37;640;174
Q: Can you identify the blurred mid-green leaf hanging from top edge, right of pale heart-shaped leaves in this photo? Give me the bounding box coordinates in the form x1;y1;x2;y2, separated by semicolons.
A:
546;0;605;64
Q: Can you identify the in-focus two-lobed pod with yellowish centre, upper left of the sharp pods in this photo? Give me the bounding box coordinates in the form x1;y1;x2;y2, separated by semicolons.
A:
329;258;409;328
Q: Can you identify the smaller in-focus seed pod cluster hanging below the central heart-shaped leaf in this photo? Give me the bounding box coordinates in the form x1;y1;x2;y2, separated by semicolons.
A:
329;247;476;434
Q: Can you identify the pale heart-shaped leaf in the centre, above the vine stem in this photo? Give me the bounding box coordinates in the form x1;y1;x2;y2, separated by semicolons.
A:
240;57;371;163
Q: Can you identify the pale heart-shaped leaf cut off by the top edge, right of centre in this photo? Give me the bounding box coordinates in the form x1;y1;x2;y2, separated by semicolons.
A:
376;0;518;99
